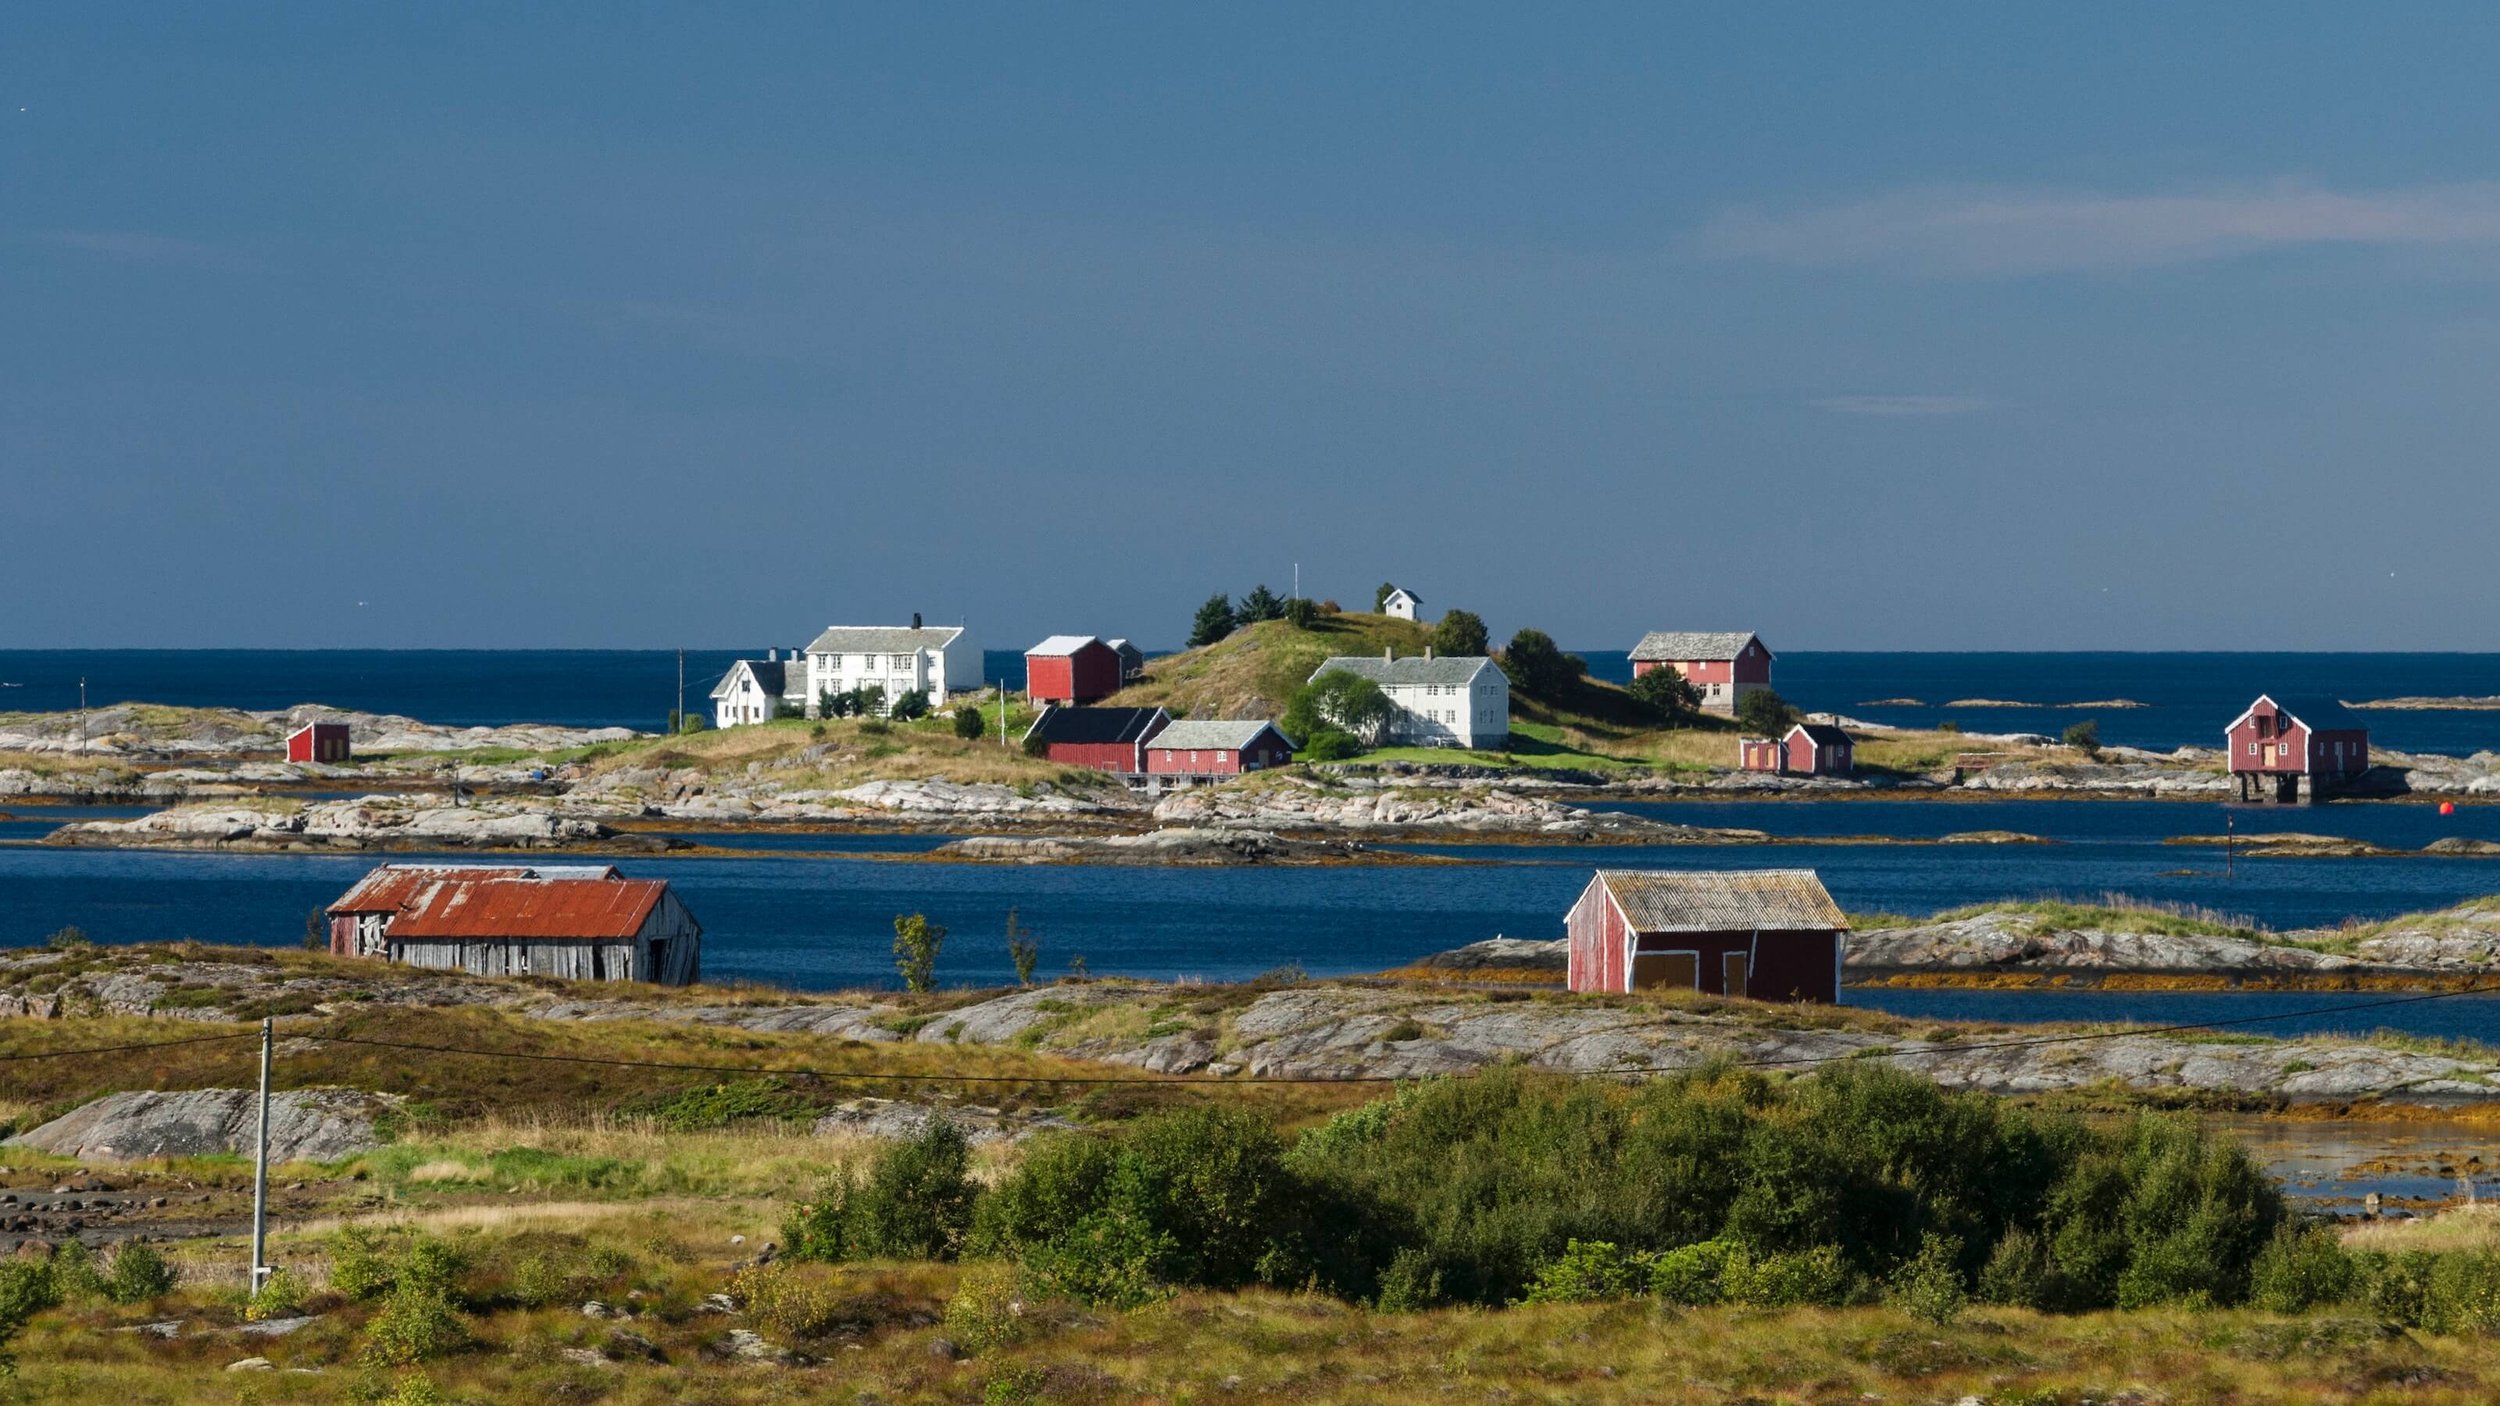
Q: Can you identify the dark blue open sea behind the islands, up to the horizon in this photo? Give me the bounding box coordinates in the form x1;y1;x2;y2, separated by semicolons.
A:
0;648;2500;756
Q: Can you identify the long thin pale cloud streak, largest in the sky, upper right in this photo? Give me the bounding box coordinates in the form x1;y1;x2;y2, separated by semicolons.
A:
1688;180;2500;278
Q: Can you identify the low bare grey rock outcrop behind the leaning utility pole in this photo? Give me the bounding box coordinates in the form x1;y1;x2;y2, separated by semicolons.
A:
8;1088;390;1161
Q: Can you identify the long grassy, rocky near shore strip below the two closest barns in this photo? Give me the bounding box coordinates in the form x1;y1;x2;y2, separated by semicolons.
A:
0;951;2500;1106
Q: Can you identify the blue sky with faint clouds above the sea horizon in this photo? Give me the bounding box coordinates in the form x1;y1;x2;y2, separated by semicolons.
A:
0;3;2500;650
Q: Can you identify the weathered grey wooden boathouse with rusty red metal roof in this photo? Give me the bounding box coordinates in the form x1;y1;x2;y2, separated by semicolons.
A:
328;863;703;986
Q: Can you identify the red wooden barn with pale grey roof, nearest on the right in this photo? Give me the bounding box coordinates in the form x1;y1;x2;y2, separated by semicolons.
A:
1565;868;1850;1003
